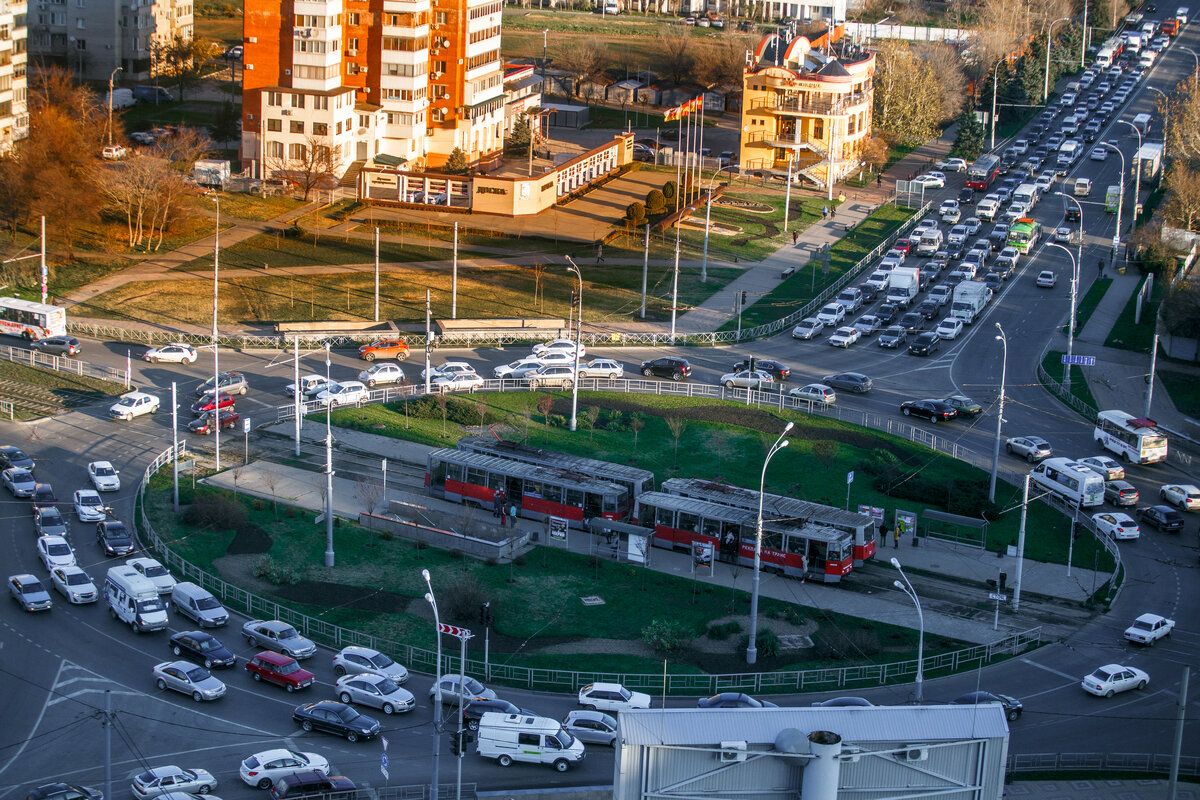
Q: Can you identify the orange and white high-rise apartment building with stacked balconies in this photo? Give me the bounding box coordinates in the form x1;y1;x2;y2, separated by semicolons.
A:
241;0;504;178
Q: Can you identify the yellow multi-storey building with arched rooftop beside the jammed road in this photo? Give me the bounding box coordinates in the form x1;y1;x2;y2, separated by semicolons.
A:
740;28;875;194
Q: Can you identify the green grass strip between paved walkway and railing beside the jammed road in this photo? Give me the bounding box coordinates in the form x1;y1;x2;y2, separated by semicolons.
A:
724;205;913;329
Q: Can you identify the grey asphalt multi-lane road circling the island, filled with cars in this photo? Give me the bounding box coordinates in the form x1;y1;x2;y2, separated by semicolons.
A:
0;18;1200;800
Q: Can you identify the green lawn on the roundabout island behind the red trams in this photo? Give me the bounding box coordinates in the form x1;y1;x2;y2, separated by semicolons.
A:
334;392;1105;567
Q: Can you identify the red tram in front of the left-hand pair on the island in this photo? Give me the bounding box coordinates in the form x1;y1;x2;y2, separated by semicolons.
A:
425;447;630;530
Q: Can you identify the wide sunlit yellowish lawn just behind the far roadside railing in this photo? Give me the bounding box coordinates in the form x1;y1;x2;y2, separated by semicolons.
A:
88;256;739;324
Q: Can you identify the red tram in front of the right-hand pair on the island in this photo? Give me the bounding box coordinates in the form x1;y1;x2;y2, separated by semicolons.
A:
637;492;854;583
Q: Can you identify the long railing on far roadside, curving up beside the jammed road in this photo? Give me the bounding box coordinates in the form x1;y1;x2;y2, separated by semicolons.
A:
67;201;932;350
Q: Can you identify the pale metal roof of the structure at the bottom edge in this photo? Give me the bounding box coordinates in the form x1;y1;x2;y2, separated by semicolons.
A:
618;704;1008;748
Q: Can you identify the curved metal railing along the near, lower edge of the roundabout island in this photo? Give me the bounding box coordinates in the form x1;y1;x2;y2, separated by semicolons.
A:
134;444;1042;696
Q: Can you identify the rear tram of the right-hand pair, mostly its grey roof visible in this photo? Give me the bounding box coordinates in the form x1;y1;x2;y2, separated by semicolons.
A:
662;477;878;566
